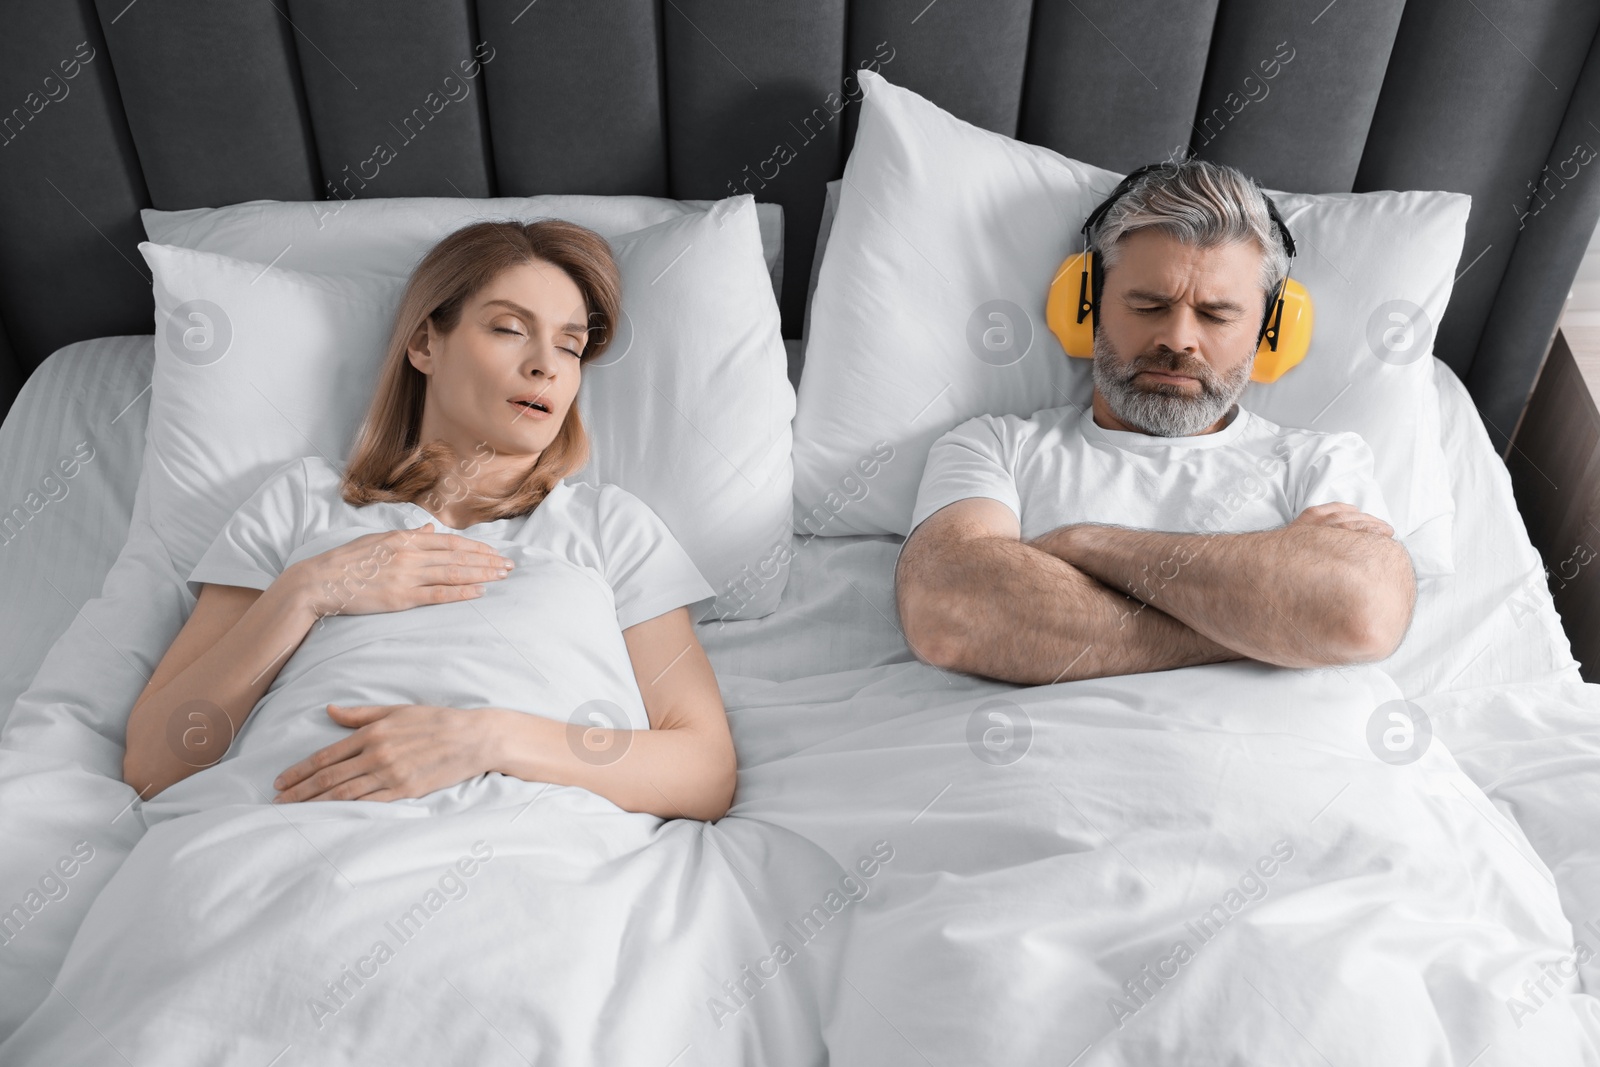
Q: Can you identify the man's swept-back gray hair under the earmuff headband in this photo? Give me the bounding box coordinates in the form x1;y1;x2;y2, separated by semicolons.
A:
1090;158;1290;308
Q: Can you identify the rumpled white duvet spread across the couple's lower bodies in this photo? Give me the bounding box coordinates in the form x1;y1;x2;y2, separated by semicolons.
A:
0;664;1600;1065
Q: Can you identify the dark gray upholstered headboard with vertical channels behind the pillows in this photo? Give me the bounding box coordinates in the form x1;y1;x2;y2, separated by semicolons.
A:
0;0;1600;446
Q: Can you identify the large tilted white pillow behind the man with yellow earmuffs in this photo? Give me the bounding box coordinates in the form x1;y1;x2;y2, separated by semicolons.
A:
795;70;1470;574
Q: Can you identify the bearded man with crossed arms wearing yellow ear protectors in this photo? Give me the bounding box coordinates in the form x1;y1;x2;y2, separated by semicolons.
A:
894;158;1416;685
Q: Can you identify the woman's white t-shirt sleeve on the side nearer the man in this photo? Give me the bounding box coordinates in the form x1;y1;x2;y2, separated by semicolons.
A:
598;485;717;630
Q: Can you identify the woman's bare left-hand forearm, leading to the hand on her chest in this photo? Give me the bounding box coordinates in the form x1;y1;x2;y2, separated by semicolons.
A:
123;571;317;798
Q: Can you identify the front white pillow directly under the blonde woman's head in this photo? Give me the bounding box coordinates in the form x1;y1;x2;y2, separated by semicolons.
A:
139;195;794;617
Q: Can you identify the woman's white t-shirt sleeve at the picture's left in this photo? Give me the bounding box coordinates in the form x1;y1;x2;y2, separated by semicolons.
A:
189;459;307;598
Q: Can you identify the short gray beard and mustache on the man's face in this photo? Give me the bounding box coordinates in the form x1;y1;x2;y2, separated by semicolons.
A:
1094;330;1256;437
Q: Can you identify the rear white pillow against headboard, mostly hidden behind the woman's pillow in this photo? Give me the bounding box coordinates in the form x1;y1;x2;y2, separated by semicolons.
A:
139;195;784;299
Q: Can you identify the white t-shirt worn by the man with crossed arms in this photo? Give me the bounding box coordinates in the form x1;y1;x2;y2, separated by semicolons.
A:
912;405;1390;541
